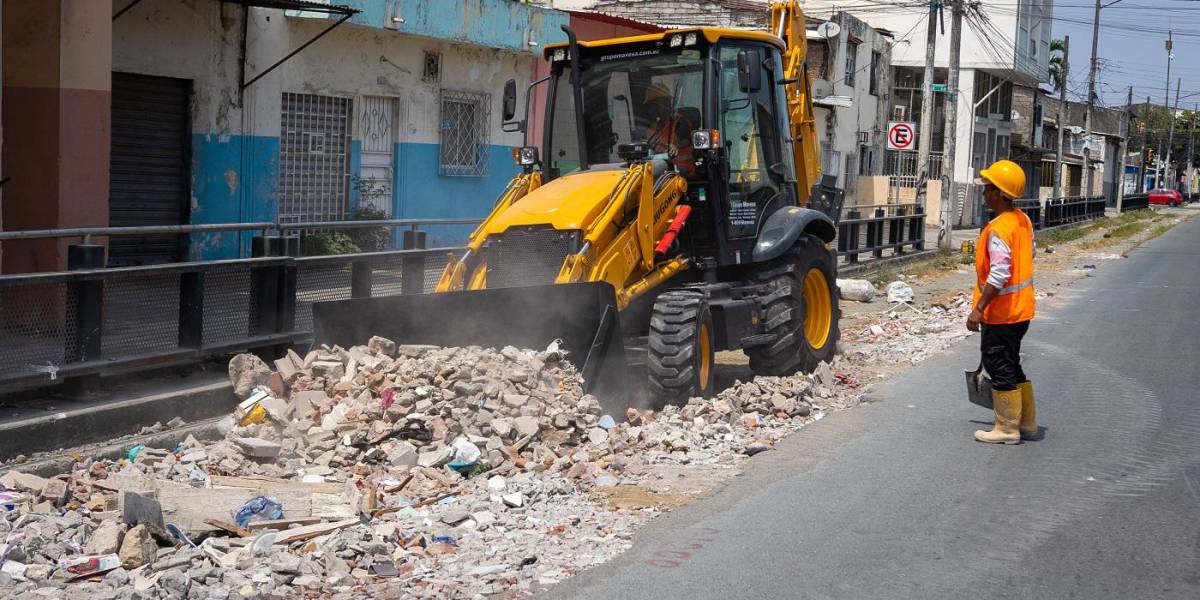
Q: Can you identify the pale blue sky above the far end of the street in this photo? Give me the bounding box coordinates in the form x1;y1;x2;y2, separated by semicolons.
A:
1046;0;1200;108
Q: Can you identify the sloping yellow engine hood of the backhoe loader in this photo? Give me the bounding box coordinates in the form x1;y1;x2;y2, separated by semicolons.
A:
487;169;625;234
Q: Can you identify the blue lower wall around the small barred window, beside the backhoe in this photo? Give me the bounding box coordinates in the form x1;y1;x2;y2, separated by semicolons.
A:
392;143;517;248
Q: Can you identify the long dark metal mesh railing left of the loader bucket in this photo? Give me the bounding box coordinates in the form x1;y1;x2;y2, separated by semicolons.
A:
0;248;461;391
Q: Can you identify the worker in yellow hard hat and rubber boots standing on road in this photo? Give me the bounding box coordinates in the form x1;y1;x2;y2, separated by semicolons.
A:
967;161;1038;444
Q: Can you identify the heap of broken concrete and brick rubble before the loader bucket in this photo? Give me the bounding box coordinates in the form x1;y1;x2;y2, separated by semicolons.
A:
0;337;858;599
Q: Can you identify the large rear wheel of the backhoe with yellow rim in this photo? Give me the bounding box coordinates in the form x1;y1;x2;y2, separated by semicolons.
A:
745;235;841;376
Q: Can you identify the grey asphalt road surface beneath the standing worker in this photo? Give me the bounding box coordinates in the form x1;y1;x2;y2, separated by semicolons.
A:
546;213;1200;600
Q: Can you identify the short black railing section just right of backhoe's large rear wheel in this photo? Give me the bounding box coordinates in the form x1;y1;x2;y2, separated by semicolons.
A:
836;204;925;264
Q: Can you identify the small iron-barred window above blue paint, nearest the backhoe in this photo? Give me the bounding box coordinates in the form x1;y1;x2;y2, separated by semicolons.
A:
438;90;492;178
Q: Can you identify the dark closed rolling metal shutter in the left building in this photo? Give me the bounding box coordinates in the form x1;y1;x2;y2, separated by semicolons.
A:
108;73;192;266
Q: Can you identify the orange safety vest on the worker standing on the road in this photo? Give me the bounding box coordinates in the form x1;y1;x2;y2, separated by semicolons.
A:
971;209;1037;325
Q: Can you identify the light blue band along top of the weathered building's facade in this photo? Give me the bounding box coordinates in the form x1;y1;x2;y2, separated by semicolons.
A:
344;0;570;53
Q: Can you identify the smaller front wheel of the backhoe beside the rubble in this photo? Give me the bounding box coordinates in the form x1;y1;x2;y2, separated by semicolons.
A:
646;289;714;402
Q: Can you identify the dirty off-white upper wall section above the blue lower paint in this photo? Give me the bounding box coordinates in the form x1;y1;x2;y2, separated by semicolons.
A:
113;0;532;145
